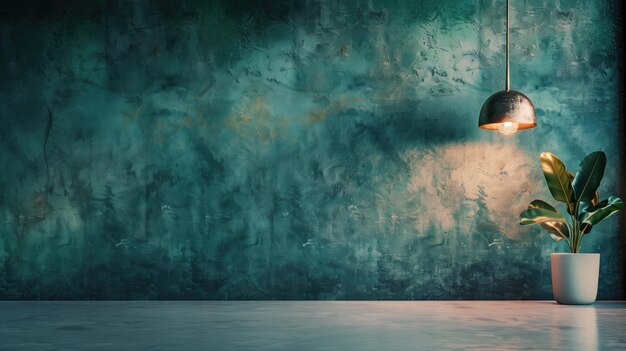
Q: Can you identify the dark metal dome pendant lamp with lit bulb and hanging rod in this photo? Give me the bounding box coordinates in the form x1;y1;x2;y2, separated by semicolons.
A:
478;0;537;135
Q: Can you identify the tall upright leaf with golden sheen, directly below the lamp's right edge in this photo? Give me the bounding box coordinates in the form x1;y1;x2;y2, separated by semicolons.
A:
539;152;576;213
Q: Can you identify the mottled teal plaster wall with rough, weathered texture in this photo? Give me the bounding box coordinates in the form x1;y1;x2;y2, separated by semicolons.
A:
0;0;624;299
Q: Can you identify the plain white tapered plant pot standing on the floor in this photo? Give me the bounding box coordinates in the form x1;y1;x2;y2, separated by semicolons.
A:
550;253;600;305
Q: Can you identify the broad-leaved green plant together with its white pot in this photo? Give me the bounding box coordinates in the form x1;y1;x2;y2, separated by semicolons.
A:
519;151;624;305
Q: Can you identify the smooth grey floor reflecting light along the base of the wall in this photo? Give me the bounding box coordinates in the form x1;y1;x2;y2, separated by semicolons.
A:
0;301;626;351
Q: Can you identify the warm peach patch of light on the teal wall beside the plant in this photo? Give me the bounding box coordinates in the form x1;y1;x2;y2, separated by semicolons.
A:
402;142;544;242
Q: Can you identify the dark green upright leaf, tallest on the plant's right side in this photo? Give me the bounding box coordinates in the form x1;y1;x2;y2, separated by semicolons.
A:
573;151;606;202
